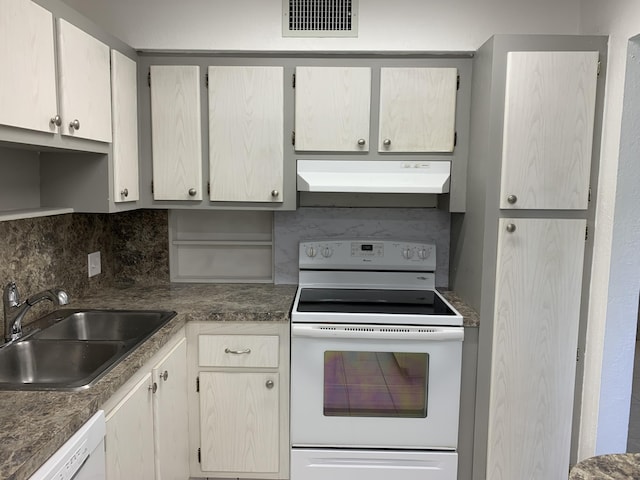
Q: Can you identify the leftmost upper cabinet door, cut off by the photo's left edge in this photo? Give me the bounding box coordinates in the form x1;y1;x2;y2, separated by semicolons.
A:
0;0;58;132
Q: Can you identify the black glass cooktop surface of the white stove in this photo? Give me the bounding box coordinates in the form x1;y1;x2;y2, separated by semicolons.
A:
297;288;455;315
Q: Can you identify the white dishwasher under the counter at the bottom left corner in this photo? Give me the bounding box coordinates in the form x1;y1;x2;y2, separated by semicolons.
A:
30;410;106;480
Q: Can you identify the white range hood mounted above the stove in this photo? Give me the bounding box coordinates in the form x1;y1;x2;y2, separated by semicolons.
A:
297;160;451;193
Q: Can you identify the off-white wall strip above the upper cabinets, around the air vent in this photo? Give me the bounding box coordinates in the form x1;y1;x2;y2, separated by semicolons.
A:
60;0;579;51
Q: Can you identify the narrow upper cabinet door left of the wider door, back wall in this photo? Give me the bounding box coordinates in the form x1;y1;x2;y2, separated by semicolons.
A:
151;65;202;200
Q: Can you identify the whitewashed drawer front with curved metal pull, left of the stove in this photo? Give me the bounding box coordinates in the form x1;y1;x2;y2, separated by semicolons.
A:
198;335;279;368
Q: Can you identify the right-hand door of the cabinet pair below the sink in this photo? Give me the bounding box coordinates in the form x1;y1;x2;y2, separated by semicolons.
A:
152;338;189;480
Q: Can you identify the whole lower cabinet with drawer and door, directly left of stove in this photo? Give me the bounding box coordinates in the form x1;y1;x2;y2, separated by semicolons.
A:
187;322;289;479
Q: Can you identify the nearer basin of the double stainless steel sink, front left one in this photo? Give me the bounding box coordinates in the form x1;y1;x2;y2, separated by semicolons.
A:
0;340;126;390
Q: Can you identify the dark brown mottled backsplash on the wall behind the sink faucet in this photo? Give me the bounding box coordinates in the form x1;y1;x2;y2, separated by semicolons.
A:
0;210;169;335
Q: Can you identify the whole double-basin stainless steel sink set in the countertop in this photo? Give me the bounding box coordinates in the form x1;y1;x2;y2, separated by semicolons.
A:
0;309;176;391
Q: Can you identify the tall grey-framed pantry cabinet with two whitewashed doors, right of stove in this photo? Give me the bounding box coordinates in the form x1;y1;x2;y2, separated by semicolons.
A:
451;35;606;480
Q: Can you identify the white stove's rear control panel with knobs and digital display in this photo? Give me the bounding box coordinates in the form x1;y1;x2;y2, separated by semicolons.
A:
299;239;436;272
